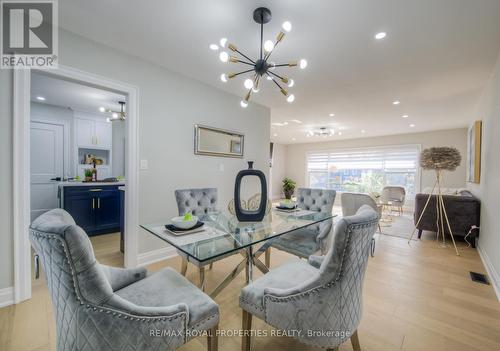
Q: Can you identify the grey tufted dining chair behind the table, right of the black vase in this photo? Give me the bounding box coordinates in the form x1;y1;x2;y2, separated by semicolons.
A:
265;188;336;267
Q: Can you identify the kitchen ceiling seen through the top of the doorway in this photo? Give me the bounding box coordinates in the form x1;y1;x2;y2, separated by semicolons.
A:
31;73;127;118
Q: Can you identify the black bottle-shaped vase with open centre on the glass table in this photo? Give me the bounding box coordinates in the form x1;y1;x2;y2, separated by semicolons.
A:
234;161;267;222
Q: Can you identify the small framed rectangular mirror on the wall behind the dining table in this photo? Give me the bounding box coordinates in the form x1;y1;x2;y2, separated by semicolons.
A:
194;124;245;158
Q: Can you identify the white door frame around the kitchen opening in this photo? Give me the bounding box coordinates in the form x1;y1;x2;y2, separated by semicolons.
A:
13;65;139;303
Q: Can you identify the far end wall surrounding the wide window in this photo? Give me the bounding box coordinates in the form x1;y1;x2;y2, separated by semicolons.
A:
285;128;467;194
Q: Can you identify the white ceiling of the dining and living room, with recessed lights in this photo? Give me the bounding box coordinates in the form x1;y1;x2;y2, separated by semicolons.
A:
59;0;500;143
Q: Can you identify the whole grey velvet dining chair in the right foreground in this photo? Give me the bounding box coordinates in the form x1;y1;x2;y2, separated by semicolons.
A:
240;205;378;351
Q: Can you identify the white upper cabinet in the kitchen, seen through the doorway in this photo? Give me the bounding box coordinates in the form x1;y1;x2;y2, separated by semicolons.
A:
76;117;113;149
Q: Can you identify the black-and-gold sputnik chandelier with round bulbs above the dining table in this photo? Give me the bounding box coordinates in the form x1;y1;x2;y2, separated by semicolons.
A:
210;7;307;108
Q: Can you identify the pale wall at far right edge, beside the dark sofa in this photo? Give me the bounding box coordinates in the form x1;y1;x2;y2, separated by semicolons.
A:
468;52;500;300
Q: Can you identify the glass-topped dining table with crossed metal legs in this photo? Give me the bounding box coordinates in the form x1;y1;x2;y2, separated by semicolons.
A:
141;209;336;297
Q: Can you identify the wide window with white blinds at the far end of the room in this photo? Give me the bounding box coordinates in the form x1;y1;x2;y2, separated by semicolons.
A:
307;145;420;196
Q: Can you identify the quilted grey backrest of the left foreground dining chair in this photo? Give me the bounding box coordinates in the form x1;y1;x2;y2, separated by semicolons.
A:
30;209;113;350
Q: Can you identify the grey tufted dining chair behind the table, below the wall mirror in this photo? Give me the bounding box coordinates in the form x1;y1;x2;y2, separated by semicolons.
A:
175;188;224;291
